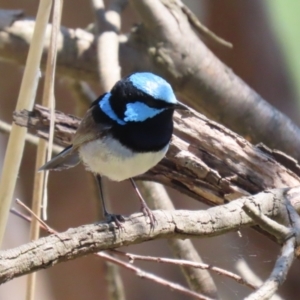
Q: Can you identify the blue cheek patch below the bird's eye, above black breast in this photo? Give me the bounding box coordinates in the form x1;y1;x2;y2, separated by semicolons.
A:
124;102;165;122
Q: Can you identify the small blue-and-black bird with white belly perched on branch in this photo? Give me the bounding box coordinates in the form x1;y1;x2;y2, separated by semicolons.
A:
39;72;188;226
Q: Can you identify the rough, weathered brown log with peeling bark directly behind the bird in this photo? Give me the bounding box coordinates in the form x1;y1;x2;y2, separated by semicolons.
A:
14;106;300;205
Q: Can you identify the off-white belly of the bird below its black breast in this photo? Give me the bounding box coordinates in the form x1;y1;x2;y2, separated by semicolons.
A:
79;137;169;181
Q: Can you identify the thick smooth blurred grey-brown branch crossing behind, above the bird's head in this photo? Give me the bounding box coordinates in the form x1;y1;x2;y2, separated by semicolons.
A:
0;7;300;159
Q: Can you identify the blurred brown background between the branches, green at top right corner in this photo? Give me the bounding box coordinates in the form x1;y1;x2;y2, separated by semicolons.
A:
0;0;300;300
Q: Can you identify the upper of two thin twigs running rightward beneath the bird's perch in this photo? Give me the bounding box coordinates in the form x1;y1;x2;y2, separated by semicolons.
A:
110;250;258;289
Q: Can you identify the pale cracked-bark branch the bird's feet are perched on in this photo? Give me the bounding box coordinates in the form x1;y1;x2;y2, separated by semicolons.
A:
0;189;300;283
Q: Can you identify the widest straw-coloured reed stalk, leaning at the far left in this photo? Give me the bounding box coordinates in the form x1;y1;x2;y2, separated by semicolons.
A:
0;0;51;244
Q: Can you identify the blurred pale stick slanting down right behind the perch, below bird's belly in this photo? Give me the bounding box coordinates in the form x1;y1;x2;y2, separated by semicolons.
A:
138;182;218;298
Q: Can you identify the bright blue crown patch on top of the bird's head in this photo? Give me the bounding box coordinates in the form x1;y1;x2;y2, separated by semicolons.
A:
129;72;177;104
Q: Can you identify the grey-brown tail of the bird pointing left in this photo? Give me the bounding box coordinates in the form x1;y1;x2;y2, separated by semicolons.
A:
39;145;80;171
